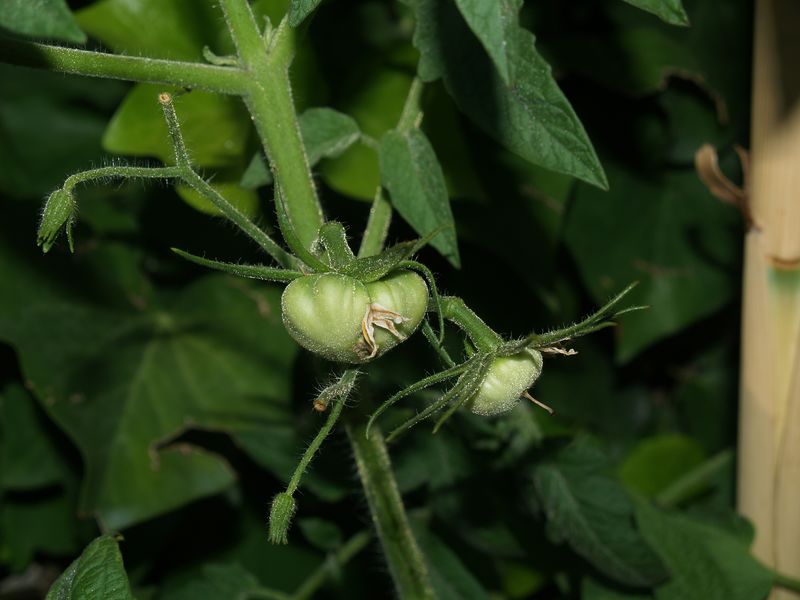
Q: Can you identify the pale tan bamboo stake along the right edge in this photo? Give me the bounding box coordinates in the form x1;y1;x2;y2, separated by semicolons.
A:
738;0;800;600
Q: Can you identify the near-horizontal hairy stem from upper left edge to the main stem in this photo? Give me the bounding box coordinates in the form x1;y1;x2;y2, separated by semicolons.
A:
0;36;247;95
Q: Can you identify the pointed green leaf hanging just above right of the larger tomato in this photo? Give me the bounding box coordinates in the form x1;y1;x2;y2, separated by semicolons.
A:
380;129;460;267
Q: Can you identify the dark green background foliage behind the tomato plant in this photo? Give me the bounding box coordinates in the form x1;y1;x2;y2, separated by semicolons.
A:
0;0;768;600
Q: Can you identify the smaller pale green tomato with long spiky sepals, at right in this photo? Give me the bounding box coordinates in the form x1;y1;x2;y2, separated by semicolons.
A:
467;349;542;417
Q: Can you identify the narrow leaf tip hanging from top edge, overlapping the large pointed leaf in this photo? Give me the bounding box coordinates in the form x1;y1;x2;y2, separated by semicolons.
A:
456;0;522;83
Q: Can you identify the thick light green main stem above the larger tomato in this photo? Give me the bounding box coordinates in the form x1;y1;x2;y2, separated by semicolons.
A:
220;0;324;249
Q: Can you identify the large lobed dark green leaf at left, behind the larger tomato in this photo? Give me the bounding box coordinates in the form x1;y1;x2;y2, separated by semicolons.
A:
0;239;295;528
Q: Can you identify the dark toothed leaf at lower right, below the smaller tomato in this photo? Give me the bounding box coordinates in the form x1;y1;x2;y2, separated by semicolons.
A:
533;439;666;586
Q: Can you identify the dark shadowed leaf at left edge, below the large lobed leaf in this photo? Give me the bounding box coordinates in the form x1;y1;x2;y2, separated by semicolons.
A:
0;385;65;490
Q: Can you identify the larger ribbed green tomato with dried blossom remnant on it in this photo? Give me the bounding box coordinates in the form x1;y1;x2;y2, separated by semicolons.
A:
281;271;428;363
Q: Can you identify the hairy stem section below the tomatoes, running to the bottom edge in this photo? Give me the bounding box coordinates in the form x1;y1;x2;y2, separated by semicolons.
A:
346;420;436;600
